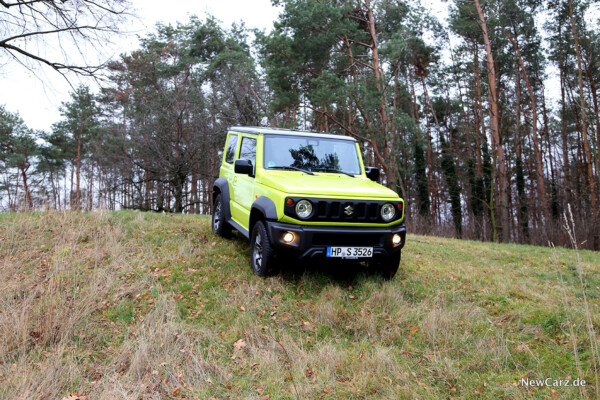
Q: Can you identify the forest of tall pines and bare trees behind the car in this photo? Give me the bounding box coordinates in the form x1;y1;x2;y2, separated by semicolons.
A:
0;0;600;250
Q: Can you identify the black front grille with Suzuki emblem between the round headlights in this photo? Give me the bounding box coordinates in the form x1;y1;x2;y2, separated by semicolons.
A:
284;197;402;223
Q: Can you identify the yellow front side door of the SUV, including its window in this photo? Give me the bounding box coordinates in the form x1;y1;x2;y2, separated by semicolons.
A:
235;135;257;229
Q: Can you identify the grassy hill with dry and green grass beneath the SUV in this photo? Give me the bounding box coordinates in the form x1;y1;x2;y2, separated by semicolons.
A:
0;212;600;400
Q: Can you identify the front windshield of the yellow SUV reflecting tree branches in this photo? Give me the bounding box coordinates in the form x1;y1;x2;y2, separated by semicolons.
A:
264;136;361;175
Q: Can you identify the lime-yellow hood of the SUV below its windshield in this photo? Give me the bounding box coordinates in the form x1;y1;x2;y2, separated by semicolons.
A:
260;171;398;199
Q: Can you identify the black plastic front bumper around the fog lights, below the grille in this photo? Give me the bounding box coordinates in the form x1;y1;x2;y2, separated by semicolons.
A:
266;221;406;259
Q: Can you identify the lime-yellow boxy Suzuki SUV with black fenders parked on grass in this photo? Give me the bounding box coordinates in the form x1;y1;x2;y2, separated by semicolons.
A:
212;127;406;279
